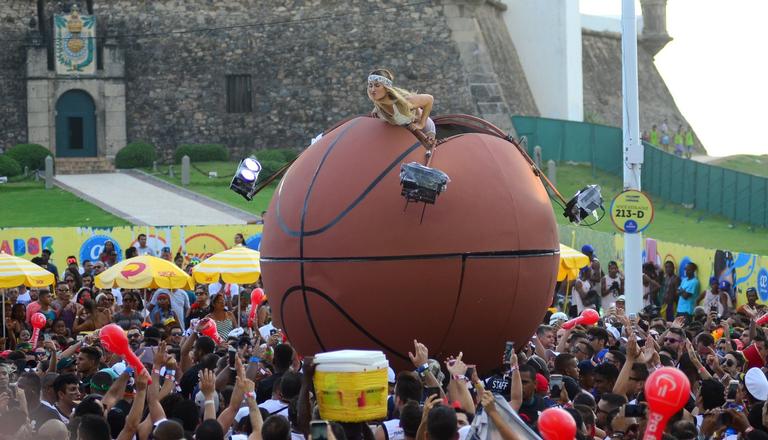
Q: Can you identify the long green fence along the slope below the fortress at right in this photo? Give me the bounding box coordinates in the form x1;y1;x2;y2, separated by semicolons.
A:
512;116;768;226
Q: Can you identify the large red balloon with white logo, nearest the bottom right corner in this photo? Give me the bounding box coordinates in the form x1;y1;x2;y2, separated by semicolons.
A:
643;367;691;439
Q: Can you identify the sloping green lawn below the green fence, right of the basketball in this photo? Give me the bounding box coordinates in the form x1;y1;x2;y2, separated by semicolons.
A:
553;165;768;255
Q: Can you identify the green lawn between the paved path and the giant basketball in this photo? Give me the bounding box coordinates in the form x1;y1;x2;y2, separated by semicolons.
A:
144;162;277;215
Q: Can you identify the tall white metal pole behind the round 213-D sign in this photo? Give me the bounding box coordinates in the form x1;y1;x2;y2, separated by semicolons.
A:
621;0;643;313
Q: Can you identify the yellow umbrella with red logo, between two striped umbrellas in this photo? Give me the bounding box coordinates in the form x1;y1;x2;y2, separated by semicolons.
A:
94;255;195;289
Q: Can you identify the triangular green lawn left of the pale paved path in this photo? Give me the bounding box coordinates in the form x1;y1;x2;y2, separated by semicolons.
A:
0;180;130;228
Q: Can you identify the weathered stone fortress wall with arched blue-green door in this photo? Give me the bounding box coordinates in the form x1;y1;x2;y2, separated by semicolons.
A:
0;0;696;168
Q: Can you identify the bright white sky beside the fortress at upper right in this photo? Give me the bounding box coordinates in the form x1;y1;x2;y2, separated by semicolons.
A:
579;0;768;156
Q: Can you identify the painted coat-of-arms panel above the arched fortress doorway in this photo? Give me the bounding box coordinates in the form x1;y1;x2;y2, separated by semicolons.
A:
53;6;96;75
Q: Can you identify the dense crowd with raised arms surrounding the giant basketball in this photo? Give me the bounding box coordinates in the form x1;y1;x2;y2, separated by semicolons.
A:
0;236;768;440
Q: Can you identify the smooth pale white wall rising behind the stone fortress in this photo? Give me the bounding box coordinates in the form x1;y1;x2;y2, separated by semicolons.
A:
504;0;583;121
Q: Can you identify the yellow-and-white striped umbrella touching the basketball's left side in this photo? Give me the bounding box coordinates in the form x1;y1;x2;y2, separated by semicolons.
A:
192;245;261;284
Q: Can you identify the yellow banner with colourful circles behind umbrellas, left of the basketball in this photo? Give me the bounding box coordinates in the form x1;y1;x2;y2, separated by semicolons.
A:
0;225;263;274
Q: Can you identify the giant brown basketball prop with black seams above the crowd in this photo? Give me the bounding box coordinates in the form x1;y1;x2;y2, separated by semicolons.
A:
261;117;559;371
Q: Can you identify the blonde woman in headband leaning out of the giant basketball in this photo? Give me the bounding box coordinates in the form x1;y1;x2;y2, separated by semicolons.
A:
367;69;436;147
